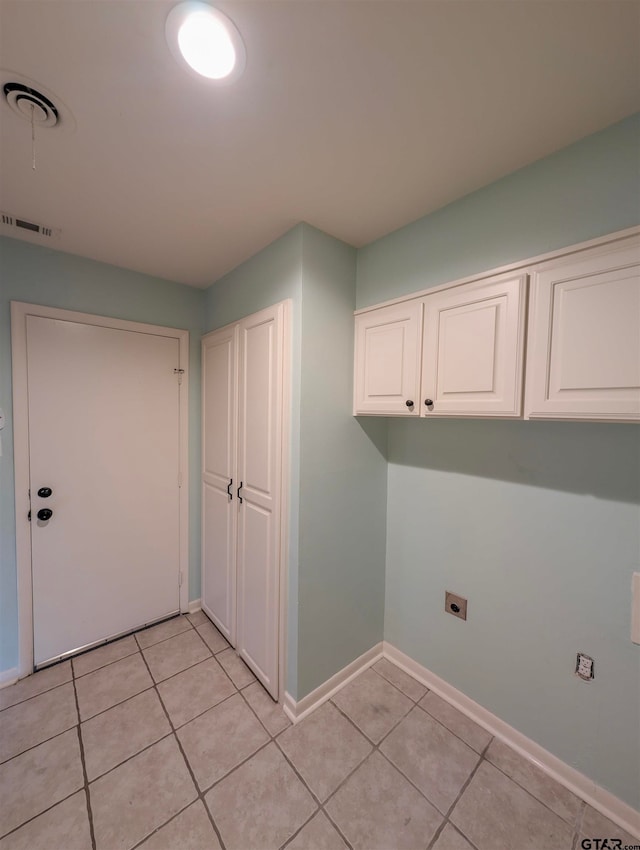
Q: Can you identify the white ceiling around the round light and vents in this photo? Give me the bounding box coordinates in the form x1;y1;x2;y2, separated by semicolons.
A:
0;0;640;286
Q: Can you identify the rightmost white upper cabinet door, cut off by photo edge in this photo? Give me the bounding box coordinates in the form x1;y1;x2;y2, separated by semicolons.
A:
526;237;640;420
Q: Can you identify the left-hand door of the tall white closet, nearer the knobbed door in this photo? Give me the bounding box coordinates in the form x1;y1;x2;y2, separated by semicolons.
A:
202;326;238;646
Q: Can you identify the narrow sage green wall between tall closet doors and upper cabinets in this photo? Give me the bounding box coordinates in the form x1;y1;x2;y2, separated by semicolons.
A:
297;225;387;699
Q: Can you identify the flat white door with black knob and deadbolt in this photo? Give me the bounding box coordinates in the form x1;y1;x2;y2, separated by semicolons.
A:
26;315;180;666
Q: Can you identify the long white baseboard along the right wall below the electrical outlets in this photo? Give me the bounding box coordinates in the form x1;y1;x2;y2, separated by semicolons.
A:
382;641;640;837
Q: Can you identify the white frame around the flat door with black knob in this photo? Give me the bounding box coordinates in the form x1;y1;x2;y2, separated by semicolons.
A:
11;301;189;678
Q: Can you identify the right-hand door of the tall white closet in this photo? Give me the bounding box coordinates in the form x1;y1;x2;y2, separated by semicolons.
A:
237;304;284;699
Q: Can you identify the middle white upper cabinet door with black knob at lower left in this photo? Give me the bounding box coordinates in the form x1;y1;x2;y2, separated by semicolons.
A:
420;274;527;417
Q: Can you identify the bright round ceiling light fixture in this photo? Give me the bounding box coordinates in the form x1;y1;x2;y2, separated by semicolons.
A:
165;0;246;83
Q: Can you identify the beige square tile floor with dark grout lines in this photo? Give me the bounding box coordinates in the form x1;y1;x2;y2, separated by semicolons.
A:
0;612;640;850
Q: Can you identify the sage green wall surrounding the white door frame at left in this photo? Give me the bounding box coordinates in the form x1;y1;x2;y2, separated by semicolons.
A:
0;237;205;672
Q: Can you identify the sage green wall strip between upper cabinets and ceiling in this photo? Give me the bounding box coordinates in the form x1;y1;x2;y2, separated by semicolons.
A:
357;113;640;307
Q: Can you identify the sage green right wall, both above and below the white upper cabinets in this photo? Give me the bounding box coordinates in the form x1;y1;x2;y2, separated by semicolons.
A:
358;115;640;807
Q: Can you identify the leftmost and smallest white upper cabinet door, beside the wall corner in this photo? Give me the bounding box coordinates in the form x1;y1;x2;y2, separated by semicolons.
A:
353;301;422;416
